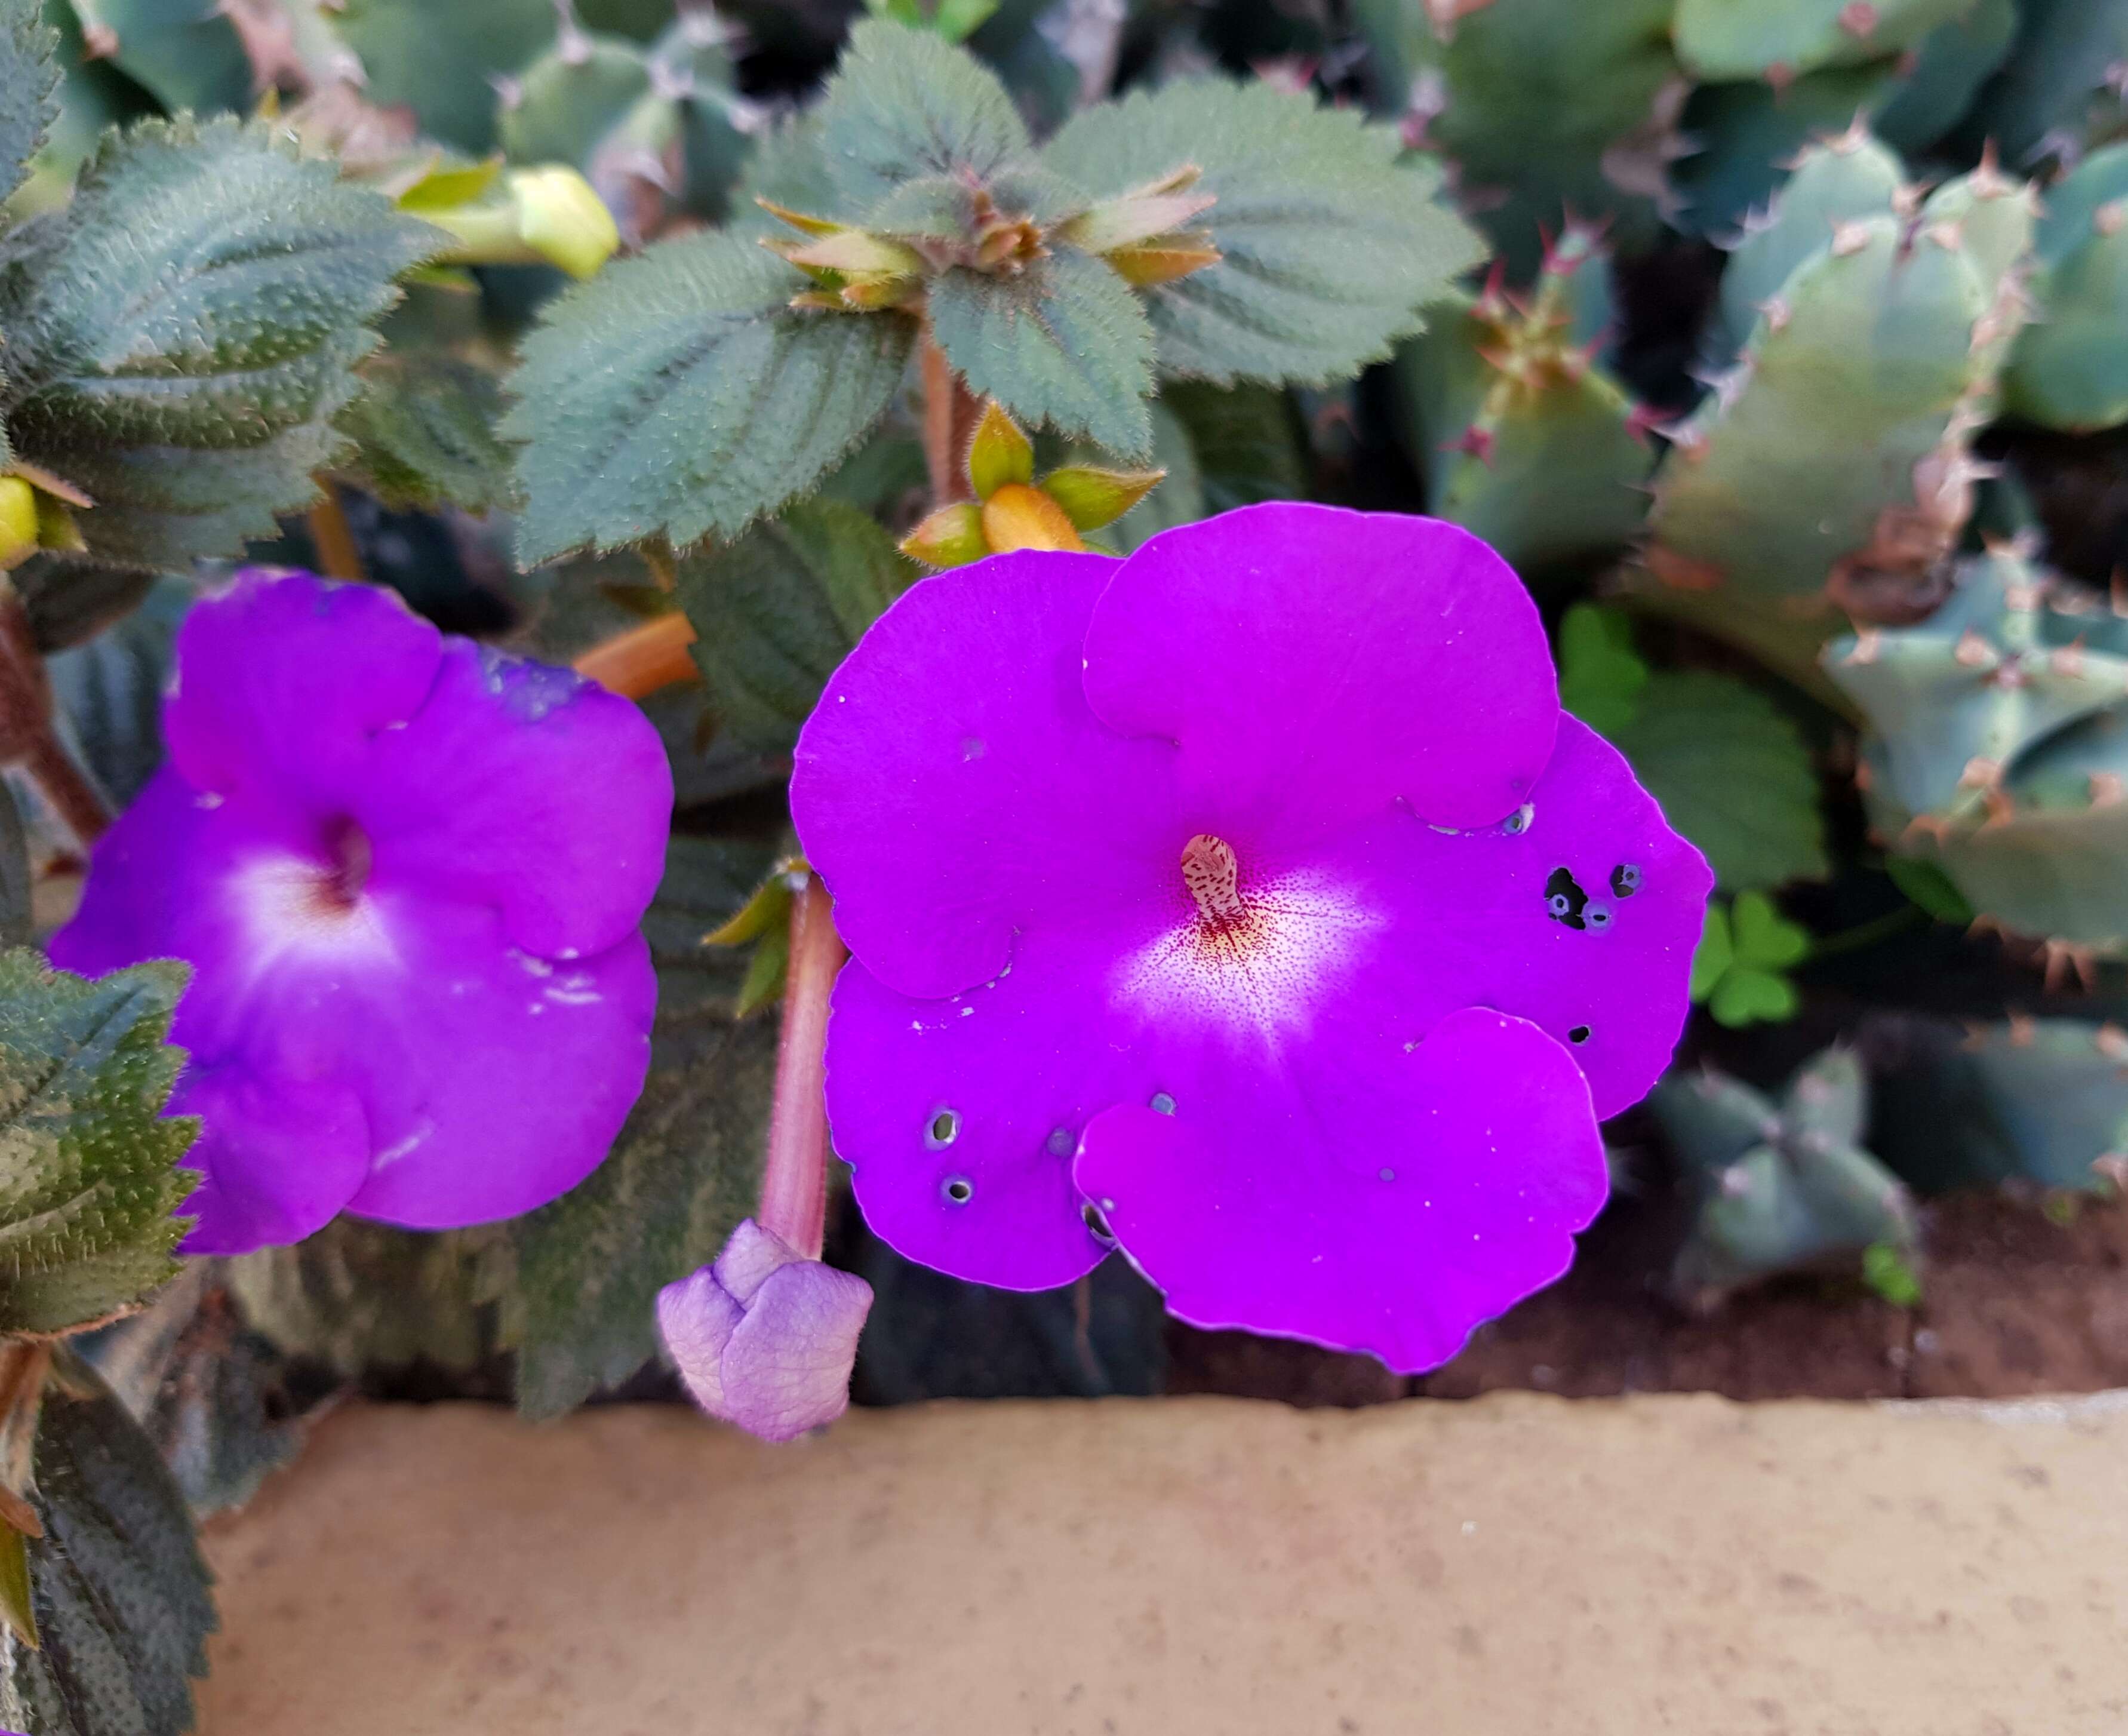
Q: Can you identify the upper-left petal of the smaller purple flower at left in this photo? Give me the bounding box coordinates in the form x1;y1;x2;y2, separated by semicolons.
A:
162;566;442;821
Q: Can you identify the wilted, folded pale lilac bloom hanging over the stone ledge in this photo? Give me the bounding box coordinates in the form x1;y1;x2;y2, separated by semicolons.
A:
657;1217;872;1440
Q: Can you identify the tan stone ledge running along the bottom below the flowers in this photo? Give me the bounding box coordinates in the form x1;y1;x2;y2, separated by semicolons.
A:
202;1393;2128;1736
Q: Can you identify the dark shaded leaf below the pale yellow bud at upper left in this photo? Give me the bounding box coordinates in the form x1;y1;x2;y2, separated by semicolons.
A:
340;353;523;513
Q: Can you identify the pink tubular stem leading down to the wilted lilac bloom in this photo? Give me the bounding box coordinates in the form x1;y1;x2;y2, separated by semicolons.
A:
755;874;847;1259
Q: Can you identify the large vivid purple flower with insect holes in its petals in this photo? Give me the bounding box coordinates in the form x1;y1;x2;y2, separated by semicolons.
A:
792;504;1709;1370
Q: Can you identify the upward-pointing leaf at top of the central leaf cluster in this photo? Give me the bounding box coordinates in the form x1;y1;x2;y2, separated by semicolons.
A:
819;19;1028;222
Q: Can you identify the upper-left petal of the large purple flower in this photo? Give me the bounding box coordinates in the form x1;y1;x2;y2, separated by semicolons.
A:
792;551;1188;995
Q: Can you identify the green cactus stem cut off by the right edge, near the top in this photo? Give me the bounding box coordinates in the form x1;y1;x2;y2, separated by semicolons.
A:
2004;145;2128;432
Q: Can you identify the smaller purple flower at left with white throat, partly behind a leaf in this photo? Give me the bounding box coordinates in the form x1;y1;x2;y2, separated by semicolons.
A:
51;570;672;1253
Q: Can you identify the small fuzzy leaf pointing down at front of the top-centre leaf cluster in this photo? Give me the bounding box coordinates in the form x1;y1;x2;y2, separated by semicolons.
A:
930;247;1154;460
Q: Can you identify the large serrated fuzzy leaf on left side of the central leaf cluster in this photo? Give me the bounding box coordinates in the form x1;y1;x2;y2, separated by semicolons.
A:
502;234;915;564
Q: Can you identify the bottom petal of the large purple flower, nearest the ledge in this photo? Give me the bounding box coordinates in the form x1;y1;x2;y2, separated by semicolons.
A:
1075;1010;1607;1372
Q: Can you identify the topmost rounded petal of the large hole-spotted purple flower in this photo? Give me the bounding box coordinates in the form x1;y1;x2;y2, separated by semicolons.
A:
1085;502;1560;844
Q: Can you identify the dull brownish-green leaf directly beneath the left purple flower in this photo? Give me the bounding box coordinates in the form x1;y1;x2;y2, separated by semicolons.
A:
226;1217;487;1376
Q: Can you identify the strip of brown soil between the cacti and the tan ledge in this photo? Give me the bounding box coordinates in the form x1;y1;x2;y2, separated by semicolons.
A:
1166;1194;2128;1406
